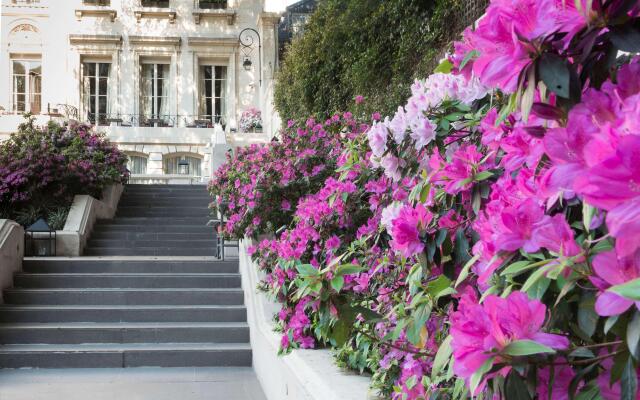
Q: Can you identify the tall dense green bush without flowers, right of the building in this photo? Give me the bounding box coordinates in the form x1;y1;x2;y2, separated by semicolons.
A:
275;0;462;120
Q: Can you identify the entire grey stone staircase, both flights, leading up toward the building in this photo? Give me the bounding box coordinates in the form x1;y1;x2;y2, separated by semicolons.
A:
0;185;251;368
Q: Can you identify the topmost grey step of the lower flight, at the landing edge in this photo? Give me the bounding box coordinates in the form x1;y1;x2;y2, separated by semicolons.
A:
22;257;238;274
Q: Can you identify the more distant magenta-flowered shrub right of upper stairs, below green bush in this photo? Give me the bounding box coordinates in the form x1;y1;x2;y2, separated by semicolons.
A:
209;113;367;237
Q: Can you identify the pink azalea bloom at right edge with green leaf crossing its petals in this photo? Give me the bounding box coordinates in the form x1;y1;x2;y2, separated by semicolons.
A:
591;250;640;317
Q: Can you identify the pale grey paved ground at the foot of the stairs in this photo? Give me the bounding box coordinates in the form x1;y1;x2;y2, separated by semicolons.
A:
0;368;265;400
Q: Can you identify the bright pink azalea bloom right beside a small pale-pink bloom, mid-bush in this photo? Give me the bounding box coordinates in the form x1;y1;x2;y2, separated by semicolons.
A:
390;204;433;257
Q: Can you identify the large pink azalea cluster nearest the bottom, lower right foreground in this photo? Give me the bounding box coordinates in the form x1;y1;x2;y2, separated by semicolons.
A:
451;289;569;390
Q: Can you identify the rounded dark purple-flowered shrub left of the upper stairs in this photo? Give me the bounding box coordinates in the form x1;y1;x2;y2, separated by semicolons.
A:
0;119;128;225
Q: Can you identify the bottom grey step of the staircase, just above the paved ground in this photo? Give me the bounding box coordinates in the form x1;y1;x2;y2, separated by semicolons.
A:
0;343;251;368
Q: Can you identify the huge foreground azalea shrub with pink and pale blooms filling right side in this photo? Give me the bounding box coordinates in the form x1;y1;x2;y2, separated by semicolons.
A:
214;0;640;400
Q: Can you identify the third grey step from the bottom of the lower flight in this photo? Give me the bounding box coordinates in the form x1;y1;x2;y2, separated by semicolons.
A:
0;305;247;323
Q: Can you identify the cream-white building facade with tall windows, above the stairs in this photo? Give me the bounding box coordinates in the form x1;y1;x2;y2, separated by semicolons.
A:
0;0;284;182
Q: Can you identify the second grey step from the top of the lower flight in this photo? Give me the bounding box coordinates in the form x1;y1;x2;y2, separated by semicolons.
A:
13;273;241;289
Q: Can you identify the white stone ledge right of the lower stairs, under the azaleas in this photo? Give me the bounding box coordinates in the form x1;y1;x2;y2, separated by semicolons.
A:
240;239;378;400
